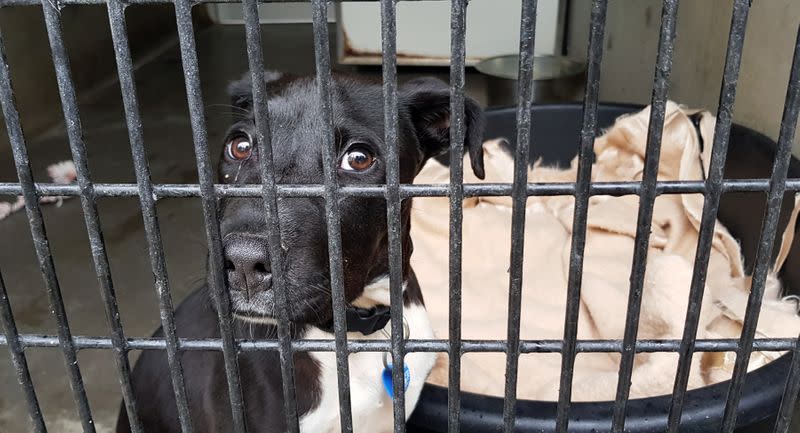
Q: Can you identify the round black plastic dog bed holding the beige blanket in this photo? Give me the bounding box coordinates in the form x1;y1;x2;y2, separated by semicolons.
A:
408;104;800;433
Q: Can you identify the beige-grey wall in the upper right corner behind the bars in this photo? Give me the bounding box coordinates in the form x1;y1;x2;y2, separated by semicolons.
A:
568;0;800;155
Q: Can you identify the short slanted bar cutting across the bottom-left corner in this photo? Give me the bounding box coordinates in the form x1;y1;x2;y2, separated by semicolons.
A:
0;268;47;433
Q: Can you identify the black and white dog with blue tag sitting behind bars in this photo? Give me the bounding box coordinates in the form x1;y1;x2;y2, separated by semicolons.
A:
117;72;483;433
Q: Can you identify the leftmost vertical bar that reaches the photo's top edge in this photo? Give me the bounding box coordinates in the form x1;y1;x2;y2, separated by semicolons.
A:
42;2;141;432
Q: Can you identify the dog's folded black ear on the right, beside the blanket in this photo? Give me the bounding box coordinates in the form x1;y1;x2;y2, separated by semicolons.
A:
398;78;485;179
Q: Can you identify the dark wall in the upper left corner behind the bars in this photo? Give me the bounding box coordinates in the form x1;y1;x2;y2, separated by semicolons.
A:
0;6;184;134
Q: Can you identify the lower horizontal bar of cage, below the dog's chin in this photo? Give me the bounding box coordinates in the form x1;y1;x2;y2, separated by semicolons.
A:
0;334;797;353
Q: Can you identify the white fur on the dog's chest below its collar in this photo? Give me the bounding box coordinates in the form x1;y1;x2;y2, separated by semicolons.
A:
300;279;436;433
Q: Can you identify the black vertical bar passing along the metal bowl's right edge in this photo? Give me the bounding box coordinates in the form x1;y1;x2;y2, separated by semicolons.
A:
556;0;608;432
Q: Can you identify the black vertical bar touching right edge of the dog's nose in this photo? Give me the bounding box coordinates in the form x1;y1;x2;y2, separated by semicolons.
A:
242;0;300;433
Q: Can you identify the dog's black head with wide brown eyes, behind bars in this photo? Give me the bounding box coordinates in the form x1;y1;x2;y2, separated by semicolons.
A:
212;72;483;325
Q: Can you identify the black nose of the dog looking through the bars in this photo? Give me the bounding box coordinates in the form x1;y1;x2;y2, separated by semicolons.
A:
225;235;272;295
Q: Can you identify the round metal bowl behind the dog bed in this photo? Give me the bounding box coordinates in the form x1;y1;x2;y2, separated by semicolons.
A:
475;54;586;107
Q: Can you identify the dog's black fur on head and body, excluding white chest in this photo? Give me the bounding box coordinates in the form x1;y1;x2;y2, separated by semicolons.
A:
117;72;483;433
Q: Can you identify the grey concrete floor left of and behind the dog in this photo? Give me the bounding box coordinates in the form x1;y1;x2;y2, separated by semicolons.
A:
0;25;485;433
